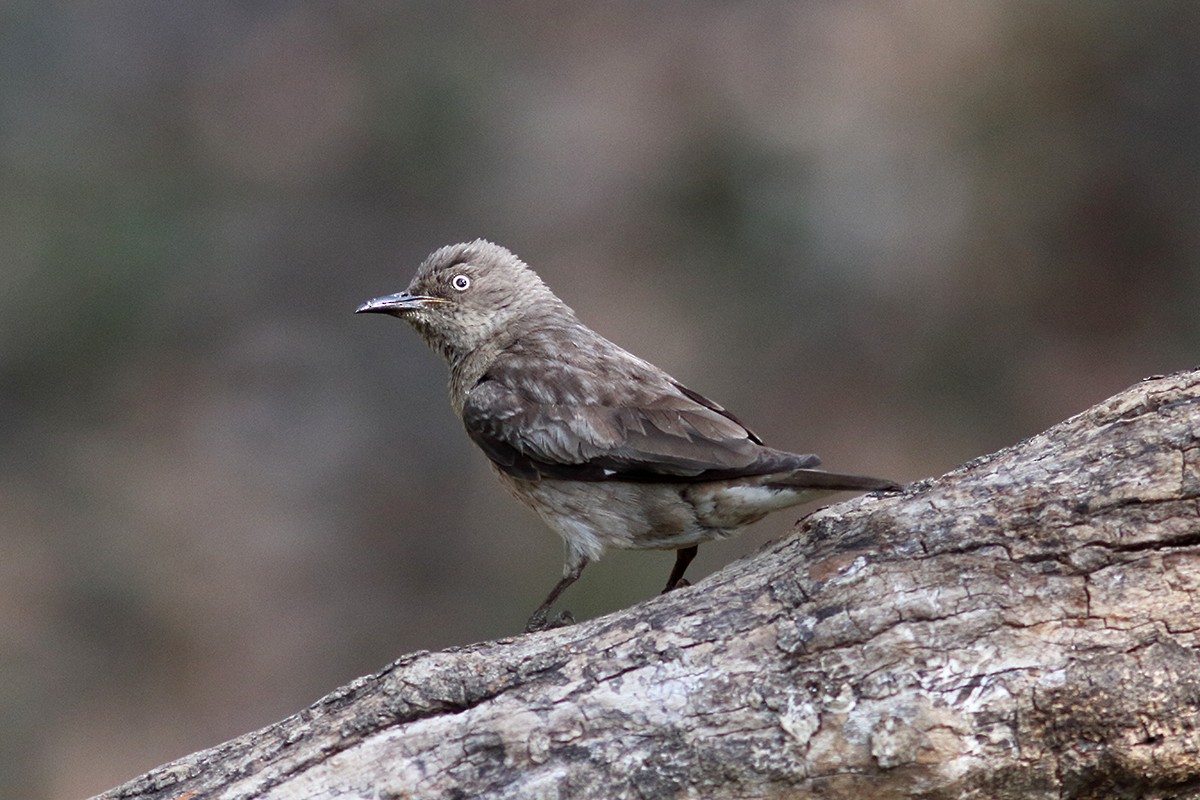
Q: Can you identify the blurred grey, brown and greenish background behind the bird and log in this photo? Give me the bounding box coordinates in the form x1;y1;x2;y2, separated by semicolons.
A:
0;0;1200;800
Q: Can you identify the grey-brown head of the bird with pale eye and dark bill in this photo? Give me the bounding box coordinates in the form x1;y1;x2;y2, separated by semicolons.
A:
355;239;574;363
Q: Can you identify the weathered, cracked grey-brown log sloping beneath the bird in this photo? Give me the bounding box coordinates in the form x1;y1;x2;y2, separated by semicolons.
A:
93;371;1200;800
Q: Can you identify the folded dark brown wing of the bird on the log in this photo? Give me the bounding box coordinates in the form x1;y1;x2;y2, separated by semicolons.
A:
462;361;820;482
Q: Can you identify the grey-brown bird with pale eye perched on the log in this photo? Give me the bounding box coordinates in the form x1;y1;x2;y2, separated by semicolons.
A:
355;239;899;632
